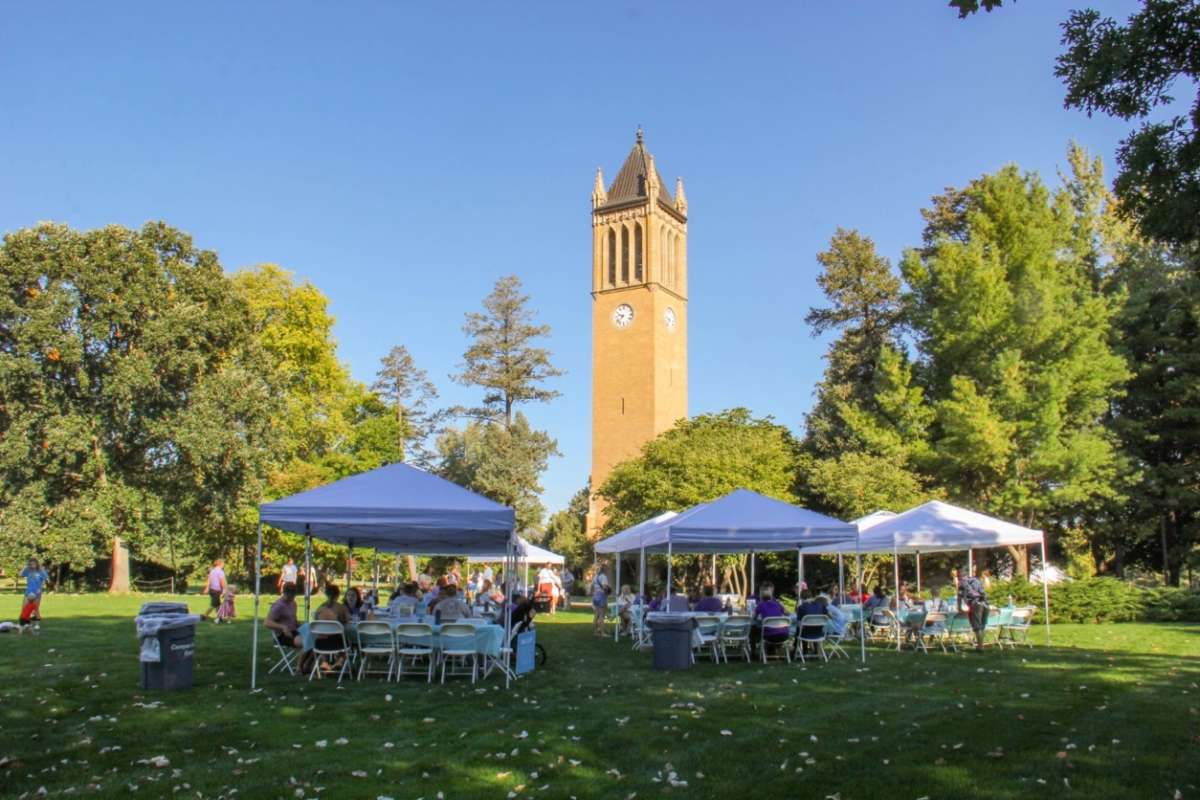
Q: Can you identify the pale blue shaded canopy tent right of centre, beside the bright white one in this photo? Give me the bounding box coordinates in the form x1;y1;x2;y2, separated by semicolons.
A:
595;489;866;661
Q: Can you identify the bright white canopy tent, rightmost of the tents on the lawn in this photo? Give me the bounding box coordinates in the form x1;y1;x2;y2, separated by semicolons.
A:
802;500;1050;642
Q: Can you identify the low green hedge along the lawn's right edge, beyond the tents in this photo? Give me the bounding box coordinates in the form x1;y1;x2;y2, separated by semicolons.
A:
988;578;1200;622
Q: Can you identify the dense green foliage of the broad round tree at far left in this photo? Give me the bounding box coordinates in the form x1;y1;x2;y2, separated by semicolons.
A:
0;223;276;570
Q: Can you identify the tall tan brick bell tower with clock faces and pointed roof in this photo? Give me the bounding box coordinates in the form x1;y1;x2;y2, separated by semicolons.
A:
587;128;688;541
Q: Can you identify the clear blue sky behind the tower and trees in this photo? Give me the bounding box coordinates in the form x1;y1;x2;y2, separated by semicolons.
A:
0;0;1136;520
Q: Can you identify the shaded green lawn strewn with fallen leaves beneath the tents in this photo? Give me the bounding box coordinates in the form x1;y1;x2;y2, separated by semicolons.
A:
0;595;1200;800
